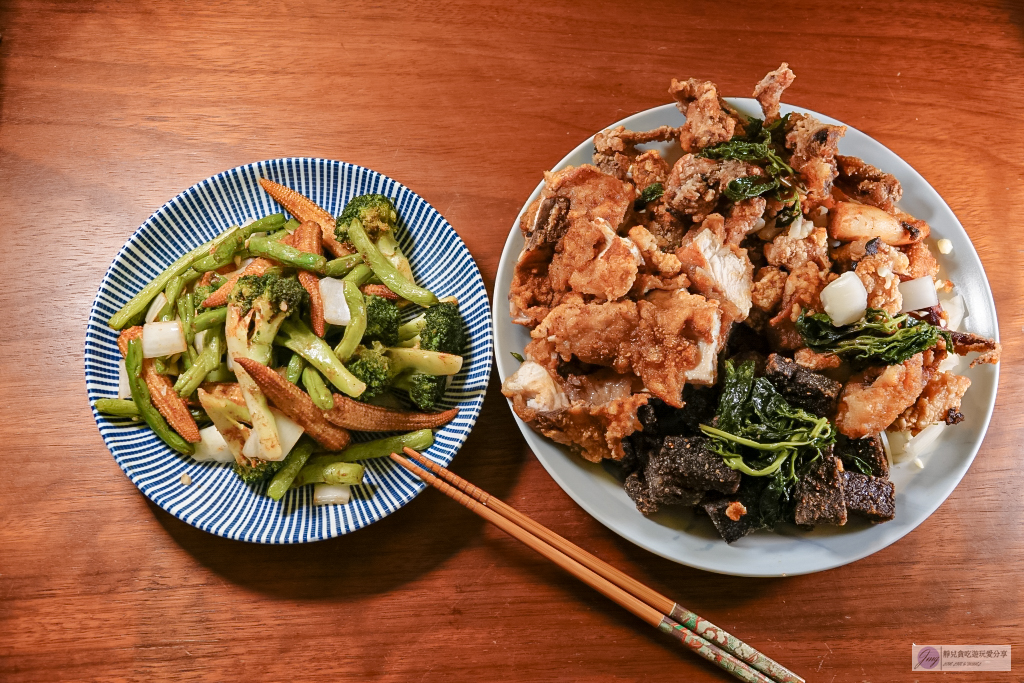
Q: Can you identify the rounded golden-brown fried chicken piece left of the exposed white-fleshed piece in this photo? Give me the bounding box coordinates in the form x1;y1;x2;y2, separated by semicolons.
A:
548;219;643;301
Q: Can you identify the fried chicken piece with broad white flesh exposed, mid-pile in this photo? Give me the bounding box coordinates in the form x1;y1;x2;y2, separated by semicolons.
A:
676;224;754;322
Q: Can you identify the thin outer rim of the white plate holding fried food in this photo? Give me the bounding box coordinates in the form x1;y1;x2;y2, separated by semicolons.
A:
492;97;1000;578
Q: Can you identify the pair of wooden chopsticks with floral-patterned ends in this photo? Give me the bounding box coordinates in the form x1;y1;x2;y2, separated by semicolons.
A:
391;449;805;683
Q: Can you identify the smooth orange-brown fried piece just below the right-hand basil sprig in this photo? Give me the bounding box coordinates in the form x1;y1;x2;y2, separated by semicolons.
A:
836;353;924;438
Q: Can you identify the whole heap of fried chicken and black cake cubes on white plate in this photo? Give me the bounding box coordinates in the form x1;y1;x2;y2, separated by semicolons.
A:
502;63;1000;543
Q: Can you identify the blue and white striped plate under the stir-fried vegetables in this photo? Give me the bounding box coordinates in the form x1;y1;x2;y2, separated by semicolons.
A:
85;159;494;543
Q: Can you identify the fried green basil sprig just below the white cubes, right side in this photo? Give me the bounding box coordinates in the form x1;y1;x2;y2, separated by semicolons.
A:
797;308;952;366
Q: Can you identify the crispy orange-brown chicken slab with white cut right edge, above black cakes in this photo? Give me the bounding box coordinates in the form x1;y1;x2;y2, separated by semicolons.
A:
633;290;722;408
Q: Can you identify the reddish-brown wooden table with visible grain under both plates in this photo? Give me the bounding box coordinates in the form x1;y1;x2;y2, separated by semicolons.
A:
0;0;1024;683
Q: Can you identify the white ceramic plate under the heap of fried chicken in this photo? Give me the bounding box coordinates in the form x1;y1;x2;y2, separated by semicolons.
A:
494;98;998;577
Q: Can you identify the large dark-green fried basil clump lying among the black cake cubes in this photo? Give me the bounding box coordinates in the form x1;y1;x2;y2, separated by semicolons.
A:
700;360;836;528
